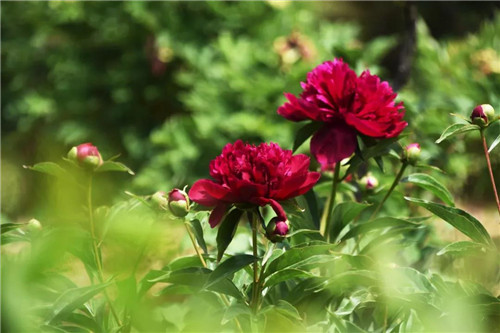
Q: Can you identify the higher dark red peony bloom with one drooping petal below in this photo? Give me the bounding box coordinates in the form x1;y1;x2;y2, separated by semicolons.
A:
278;59;408;169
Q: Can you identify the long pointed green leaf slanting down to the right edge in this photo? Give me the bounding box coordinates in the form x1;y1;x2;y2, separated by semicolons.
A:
405;197;494;247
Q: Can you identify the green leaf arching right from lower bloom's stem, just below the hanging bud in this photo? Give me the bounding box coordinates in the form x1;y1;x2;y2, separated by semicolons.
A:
263;243;335;278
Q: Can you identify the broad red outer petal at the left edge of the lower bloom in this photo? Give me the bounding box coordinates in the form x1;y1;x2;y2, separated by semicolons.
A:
189;179;232;207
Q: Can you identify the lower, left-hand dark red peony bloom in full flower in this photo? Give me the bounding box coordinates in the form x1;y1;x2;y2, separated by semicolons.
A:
189;140;320;228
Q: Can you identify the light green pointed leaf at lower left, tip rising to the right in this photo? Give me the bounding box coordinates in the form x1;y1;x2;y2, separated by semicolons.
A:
46;281;112;324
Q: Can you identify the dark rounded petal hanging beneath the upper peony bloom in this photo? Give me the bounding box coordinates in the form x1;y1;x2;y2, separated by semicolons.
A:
311;122;357;170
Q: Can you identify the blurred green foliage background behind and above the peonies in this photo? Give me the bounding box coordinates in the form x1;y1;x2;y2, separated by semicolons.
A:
1;1;500;228
